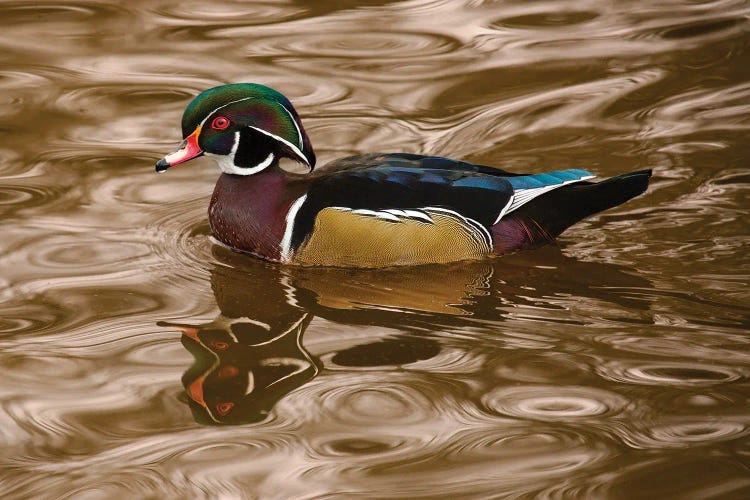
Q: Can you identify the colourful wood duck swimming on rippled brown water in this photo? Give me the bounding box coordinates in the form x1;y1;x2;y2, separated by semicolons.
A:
156;83;651;267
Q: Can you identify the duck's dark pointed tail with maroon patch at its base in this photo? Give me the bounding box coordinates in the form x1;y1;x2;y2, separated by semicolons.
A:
492;170;651;254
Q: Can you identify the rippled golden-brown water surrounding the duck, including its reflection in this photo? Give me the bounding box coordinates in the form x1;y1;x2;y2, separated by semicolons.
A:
0;0;750;498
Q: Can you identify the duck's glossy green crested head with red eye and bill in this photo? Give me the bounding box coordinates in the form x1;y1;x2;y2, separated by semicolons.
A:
156;83;315;175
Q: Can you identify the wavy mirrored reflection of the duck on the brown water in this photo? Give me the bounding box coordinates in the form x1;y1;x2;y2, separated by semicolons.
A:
159;247;643;425
